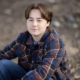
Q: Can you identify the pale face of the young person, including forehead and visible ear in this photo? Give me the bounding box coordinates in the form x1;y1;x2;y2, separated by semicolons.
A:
27;9;49;41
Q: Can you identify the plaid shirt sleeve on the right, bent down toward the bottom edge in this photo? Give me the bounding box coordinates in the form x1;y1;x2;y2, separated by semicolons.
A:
21;40;69;80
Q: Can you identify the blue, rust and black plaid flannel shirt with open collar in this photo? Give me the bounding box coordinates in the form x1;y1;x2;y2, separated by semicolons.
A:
0;29;71;80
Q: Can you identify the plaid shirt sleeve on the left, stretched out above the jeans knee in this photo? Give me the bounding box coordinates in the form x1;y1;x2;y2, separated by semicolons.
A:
0;34;20;60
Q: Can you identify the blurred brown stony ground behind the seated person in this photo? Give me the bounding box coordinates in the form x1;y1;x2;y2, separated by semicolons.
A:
0;0;80;80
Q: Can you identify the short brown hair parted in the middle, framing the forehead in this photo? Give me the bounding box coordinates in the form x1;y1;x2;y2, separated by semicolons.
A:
25;3;53;28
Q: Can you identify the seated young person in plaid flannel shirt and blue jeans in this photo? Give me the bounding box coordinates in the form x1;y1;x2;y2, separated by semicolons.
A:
0;3;71;80
